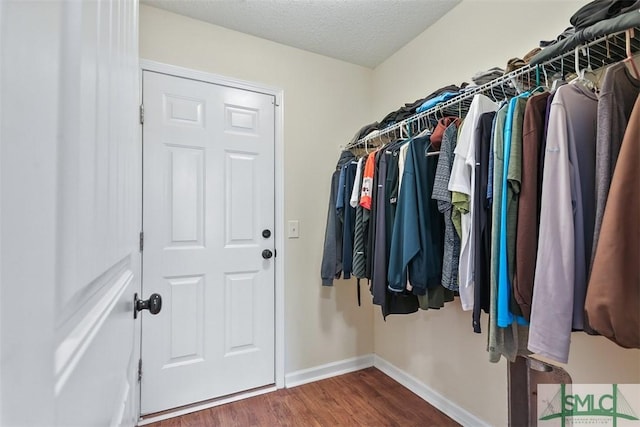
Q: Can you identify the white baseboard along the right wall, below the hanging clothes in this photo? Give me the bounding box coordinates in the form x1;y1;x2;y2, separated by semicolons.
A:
373;355;491;427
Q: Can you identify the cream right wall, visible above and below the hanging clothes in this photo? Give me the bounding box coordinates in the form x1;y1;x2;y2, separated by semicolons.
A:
373;0;640;426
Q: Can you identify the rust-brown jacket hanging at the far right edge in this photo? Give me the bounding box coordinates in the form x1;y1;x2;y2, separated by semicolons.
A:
585;96;640;348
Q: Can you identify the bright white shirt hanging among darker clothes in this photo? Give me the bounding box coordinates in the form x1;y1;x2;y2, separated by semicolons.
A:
448;95;497;310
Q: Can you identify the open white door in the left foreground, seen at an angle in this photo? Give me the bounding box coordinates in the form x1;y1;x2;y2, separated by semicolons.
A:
0;0;141;426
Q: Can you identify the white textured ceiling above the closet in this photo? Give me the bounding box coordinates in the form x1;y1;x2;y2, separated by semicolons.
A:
141;0;460;68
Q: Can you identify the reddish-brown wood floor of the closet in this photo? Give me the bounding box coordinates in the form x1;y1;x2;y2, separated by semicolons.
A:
150;368;459;427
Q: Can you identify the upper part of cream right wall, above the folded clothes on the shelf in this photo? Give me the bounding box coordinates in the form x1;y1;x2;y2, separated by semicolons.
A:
373;0;588;118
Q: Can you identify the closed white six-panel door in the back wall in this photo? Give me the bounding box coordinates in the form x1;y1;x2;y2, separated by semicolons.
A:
141;71;275;414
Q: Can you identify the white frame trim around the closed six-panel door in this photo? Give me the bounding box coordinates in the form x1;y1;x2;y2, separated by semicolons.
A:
136;59;285;425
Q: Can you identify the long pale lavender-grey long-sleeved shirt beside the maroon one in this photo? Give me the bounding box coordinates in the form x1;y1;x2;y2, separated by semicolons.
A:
529;84;598;363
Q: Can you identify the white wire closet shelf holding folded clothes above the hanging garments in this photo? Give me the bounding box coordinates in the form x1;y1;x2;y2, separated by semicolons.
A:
345;27;640;150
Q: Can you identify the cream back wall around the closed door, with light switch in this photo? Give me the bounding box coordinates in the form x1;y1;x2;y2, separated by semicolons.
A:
140;5;373;373
